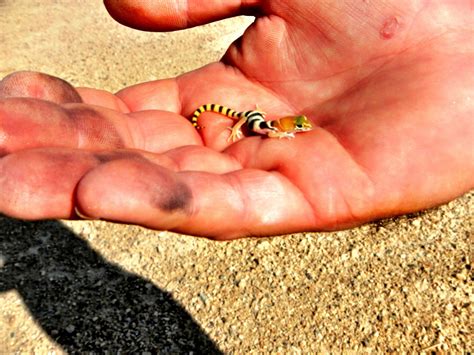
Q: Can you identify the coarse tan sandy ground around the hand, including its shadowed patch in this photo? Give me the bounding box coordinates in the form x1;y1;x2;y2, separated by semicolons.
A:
0;0;474;354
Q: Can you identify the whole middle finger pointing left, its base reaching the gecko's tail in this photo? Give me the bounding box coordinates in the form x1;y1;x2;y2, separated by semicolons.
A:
0;98;201;154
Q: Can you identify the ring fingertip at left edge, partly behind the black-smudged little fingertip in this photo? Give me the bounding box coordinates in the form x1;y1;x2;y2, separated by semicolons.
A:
0;149;97;220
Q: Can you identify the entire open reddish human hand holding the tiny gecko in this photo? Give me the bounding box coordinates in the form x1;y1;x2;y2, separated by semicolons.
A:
0;0;474;239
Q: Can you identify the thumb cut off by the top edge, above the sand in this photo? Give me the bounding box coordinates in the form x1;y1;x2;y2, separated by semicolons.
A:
104;0;260;31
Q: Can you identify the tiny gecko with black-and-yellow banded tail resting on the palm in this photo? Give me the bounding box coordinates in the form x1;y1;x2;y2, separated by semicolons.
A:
191;104;313;142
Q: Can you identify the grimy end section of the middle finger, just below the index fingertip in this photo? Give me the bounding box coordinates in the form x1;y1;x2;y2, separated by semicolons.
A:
0;98;133;153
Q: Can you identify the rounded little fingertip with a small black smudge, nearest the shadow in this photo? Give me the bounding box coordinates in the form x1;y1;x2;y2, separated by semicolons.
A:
76;159;192;229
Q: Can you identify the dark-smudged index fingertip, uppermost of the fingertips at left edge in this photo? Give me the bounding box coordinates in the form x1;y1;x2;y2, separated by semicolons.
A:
0;71;82;104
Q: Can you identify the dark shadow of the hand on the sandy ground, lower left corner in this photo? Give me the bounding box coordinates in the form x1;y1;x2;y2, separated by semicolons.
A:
0;215;221;354
